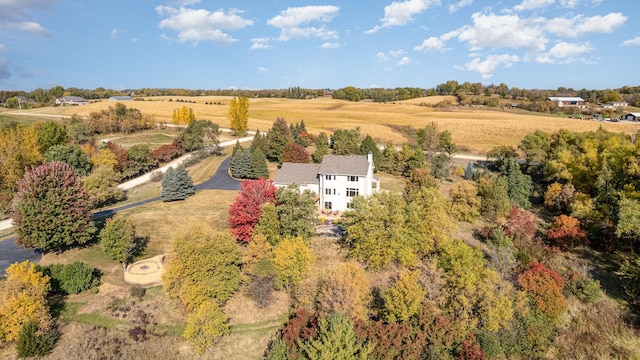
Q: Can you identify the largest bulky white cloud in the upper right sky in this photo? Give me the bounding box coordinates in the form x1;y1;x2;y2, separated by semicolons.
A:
457;13;549;51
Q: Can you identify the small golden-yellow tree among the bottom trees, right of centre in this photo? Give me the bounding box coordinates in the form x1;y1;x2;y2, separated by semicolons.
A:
382;271;427;322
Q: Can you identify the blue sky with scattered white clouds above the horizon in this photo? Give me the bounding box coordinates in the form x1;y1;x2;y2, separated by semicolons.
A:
0;0;640;91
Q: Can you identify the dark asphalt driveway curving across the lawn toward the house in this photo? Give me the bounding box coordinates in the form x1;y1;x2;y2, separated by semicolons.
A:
0;157;240;277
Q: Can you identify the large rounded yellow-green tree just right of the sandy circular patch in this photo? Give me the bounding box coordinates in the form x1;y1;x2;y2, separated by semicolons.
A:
162;225;242;311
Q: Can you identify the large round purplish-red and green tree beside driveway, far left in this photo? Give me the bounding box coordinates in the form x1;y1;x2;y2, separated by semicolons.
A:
12;161;95;252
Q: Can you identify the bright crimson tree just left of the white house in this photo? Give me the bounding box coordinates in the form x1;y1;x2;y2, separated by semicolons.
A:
228;178;276;243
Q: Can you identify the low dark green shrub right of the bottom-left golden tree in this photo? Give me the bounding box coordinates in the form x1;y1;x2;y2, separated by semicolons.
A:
40;261;100;294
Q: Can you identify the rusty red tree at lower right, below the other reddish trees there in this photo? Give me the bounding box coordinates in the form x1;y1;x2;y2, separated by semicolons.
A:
518;261;567;320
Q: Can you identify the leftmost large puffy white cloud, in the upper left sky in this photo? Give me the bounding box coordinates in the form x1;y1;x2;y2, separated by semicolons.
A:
156;6;253;44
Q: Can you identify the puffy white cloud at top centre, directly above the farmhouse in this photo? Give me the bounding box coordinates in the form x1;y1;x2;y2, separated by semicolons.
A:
267;5;340;41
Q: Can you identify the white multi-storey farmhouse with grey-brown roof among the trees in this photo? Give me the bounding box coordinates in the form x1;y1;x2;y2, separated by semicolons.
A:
273;154;380;211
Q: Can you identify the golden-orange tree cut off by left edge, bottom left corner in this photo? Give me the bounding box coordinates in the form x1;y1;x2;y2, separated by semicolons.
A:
0;261;52;345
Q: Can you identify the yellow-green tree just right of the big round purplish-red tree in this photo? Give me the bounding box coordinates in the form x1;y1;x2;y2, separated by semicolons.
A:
82;166;125;209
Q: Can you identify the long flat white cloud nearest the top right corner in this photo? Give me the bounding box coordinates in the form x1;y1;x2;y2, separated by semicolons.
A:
545;13;627;38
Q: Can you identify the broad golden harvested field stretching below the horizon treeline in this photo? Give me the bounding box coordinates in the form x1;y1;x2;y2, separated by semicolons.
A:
41;96;638;153
